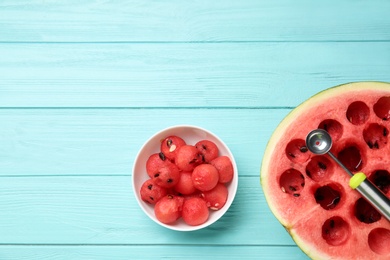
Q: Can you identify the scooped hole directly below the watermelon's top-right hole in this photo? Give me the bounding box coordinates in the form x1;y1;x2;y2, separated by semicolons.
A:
363;123;389;149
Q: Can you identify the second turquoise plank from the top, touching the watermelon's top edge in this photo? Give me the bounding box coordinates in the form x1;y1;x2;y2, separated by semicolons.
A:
0;42;390;108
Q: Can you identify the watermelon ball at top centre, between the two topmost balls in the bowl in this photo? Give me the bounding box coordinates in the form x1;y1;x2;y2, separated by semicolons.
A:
175;145;202;172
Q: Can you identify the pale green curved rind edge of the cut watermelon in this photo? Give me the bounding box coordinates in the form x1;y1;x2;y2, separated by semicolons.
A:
260;81;390;259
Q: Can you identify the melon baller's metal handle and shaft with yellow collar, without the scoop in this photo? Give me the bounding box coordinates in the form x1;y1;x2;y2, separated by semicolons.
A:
328;152;390;221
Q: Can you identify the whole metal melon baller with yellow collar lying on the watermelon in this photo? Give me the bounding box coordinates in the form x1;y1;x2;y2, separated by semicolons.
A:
306;129;390;221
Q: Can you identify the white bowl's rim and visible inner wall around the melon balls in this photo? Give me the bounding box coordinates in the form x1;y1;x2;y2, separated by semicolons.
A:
132;125;238;231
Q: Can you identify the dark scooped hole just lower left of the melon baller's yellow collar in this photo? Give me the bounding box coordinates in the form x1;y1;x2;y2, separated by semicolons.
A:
314;183;344;210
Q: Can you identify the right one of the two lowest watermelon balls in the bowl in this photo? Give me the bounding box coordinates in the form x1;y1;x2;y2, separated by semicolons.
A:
182;197;210;226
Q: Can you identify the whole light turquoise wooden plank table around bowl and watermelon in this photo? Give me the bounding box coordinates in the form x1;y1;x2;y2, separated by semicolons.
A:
0;0;390;259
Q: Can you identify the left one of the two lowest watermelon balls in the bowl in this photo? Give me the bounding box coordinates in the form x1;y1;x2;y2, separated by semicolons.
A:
154;195;184;224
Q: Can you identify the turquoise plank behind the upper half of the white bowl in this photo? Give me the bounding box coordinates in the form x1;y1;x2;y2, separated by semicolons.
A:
0;109;290;176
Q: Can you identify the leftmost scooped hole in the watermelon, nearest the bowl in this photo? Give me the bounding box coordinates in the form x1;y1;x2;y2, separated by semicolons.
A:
279;169;305;197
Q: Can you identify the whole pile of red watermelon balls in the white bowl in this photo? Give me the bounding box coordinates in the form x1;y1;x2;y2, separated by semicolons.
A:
140;135;234;226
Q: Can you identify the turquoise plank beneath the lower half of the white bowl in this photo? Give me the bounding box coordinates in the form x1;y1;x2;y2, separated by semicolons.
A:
0;176;295;249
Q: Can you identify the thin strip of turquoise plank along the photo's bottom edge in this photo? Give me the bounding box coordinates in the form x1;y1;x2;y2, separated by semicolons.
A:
0;245;309;260
